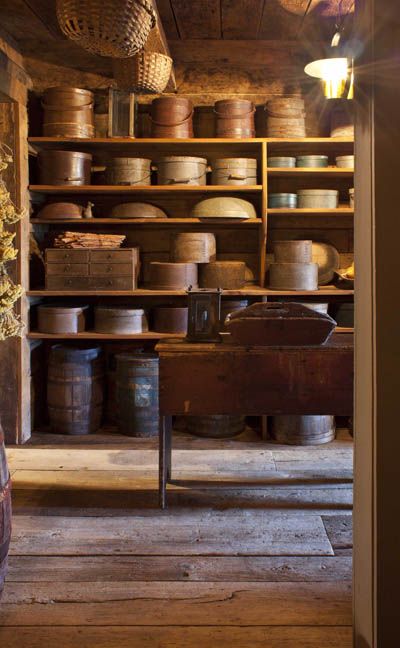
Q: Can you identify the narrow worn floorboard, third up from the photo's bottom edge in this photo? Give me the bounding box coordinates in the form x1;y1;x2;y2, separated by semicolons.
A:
8;555;352;583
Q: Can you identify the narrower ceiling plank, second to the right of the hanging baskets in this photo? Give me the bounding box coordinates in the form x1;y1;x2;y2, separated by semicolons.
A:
221;0;268;40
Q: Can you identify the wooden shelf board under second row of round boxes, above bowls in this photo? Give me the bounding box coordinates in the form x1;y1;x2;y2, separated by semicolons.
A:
29;185;262;195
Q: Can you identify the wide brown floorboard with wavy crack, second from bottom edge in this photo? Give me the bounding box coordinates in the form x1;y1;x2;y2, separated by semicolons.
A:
0;581;351;627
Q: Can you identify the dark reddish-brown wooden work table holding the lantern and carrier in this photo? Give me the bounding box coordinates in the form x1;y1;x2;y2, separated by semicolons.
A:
156;334;353;508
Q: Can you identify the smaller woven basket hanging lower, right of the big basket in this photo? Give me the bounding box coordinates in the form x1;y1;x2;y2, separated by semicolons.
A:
113;51;172;94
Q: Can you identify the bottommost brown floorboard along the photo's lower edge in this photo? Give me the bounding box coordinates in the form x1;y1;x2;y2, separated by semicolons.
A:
0;626;352;648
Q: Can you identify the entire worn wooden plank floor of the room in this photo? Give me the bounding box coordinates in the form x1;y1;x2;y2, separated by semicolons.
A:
0;431;352;648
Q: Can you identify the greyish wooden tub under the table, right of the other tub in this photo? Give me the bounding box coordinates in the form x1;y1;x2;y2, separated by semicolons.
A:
272;414;335;445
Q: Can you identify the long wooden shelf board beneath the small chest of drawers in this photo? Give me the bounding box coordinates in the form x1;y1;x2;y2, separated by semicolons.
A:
26;286;354;297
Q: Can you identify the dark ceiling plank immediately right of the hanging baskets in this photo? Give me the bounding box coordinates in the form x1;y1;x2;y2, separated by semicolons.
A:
171;0;221;39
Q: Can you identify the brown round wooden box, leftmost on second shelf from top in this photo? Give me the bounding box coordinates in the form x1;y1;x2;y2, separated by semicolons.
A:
38;150;92;186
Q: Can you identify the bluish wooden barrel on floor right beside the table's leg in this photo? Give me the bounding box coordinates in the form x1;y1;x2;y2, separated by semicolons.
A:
116;353;159;437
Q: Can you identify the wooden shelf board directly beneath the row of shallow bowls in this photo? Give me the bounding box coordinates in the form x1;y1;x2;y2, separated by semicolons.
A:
30;218;262;228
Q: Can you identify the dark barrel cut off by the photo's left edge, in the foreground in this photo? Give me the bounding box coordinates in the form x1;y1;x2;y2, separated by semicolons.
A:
0;425;11;597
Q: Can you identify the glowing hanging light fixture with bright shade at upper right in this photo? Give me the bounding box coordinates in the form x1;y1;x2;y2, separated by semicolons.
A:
304;0;354;99
